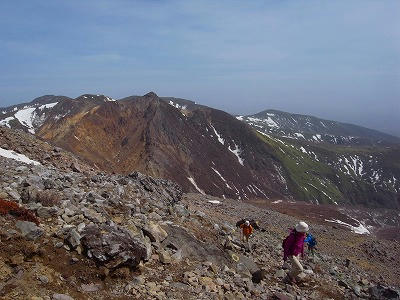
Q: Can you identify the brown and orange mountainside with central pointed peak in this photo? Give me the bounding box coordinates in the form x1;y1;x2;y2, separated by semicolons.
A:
37;93;287;199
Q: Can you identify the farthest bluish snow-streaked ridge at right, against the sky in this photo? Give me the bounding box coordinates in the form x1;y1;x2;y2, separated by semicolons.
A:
237;110;400;145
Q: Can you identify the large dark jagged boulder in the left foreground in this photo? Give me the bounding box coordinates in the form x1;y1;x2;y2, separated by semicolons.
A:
81;224;148;270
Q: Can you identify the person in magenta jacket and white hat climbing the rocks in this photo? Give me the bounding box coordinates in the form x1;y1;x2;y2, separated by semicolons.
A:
282;221;308;283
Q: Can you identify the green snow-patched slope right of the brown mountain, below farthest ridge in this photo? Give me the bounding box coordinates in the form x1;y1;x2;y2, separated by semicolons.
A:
258;133;400;207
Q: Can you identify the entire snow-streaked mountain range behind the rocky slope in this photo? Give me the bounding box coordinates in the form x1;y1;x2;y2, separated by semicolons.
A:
0;93;400;208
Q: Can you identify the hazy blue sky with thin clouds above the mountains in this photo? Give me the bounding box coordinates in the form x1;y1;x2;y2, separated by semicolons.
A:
0;0;400;136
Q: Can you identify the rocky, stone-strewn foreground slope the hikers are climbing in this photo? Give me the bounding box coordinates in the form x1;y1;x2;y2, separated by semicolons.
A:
0;127;400;300
